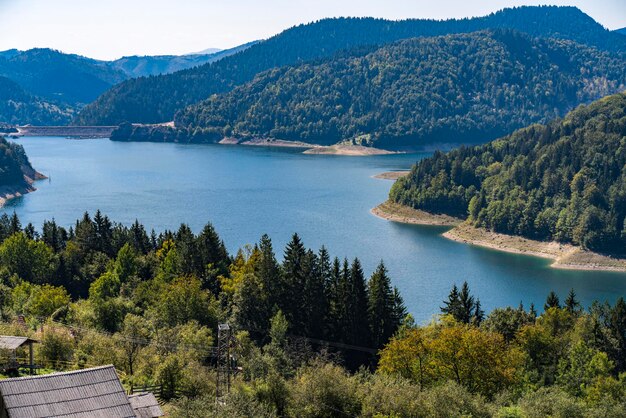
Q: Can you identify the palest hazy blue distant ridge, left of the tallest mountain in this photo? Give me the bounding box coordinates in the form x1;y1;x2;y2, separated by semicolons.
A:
107;42;256;78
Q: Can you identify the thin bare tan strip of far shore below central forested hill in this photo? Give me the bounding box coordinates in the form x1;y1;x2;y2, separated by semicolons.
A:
218;138;399;157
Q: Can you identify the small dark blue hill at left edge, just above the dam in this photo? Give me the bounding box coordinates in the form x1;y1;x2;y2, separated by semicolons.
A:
0;77;73;125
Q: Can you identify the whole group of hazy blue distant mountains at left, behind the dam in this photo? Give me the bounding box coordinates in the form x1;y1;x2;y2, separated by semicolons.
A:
0;42;254;124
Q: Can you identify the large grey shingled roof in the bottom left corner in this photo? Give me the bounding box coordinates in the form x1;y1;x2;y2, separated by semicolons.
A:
0;366;135;418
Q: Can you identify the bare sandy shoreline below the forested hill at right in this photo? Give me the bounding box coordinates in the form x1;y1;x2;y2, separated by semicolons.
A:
371;202;626;272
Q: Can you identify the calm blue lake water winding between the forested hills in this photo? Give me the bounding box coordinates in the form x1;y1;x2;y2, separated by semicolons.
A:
1;138;626;321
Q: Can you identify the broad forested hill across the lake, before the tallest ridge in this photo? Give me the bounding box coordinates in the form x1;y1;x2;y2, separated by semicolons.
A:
176;30;626;149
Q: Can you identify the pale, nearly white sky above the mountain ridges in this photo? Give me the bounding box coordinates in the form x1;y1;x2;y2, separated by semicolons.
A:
0;0;626;59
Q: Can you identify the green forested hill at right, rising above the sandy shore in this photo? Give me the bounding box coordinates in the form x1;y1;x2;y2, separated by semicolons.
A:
390;93;626;254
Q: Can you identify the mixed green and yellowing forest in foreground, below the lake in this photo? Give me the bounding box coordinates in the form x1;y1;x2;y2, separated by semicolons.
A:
0;212;626;418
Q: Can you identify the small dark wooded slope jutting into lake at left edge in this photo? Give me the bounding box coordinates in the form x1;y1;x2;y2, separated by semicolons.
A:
0;136;36;187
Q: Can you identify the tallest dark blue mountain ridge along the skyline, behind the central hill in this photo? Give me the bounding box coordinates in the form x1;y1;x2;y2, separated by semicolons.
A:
76;6;626;125
